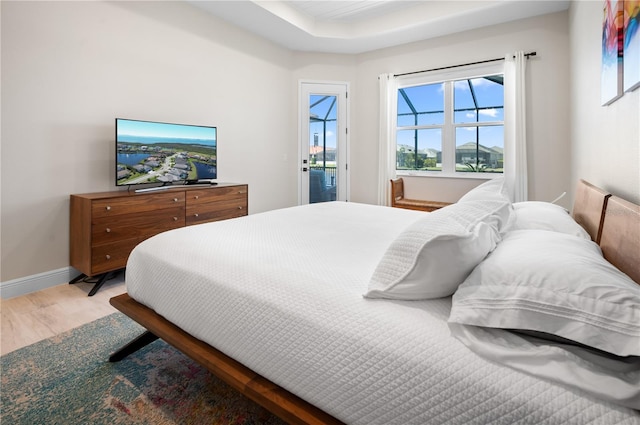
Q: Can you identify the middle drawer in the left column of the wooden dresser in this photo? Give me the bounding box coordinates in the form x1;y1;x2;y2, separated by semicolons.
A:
91;206;185;246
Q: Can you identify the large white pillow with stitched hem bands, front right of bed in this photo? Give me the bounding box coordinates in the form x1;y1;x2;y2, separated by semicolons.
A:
449;230;640;356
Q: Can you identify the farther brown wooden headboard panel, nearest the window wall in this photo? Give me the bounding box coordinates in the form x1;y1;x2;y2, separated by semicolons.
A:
572;180;611;243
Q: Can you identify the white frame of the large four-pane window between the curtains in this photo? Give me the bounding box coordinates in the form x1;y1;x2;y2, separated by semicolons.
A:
391;61;507;180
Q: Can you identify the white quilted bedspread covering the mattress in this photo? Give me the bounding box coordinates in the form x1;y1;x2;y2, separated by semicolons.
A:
126;202;640;425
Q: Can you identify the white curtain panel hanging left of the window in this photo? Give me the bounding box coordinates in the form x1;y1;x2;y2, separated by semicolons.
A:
378;74;397;205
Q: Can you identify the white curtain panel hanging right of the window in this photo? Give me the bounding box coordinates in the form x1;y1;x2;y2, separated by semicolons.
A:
504;52;528;202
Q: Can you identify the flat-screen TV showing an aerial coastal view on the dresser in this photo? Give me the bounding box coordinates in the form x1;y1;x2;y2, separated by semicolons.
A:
116;118;218;186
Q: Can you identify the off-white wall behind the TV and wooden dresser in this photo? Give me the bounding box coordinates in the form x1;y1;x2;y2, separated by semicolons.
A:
0;1;297;283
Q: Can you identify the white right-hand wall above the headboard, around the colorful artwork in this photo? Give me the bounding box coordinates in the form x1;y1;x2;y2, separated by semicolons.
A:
570;2;640;203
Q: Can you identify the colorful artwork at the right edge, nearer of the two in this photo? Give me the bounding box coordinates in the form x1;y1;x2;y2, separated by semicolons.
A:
623;0;640;92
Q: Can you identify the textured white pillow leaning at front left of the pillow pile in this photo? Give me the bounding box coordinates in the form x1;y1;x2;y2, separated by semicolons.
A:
364;201;510;300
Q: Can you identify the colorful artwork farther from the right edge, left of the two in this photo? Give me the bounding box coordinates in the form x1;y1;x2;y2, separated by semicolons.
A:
600;0;623;105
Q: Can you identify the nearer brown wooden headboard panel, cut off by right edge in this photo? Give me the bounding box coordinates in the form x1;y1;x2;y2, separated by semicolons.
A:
599;196;640;284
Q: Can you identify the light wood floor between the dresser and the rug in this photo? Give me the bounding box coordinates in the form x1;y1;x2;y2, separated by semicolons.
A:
0;273;125;355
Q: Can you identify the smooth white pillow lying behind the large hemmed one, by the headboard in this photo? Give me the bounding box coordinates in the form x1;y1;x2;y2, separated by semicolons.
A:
509;201;591;240
